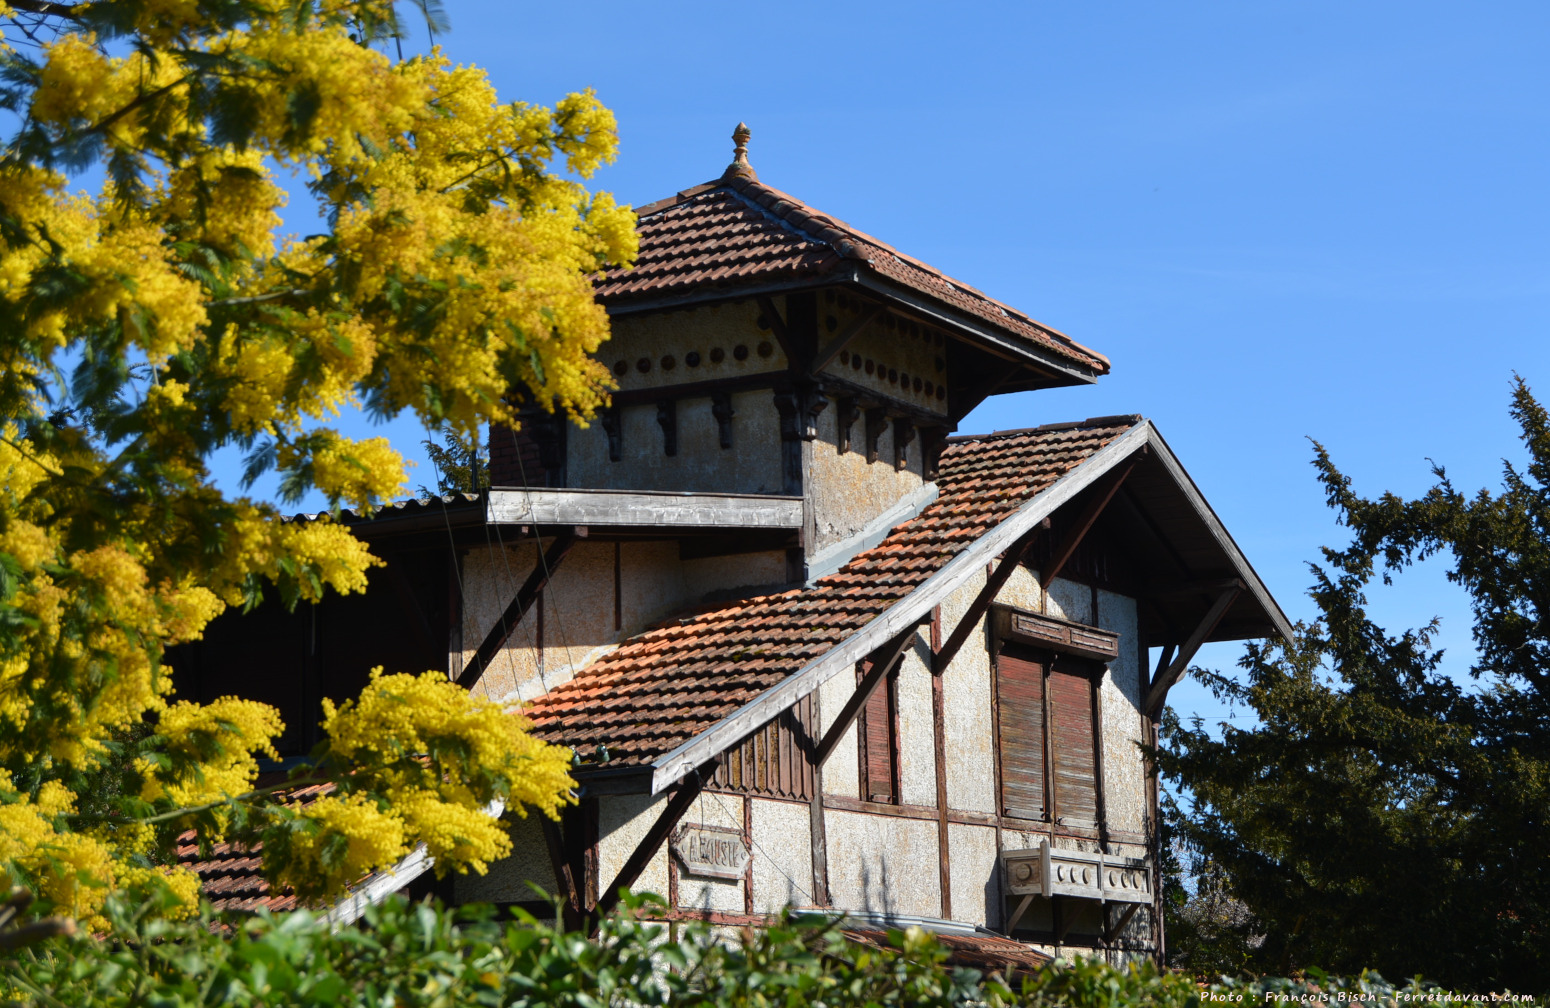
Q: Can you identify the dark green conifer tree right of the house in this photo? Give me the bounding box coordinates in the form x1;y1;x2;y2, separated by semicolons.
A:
1158;378;1550;992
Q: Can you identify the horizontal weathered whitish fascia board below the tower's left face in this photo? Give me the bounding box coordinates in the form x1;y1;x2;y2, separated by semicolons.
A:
485;487;803;529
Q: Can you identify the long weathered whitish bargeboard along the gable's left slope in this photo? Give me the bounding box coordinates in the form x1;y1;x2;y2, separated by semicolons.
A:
651;420;1152;794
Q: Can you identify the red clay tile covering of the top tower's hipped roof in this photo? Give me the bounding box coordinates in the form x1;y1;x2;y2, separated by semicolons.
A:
595;178;1108;374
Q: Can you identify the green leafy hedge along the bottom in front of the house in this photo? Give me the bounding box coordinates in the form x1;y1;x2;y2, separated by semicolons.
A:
0;896;1531;1008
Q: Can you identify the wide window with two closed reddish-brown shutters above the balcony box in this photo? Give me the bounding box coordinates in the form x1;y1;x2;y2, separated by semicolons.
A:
995;644;1102;828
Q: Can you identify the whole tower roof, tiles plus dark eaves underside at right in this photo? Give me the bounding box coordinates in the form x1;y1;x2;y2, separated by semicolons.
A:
595;177;1110;392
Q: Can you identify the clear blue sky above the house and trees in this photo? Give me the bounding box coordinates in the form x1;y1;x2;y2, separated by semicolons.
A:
254;0;1550;715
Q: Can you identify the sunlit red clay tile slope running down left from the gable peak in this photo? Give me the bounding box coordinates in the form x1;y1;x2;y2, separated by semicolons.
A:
524;417;1141;768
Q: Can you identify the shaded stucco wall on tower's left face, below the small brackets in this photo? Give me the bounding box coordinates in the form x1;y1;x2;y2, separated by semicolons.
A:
566;389;784;493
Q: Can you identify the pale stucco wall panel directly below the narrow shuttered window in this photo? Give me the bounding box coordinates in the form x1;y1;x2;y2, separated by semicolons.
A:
823;808;942;917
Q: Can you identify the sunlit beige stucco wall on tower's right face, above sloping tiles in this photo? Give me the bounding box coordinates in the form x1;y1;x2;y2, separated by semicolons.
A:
804;392;925;555
